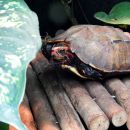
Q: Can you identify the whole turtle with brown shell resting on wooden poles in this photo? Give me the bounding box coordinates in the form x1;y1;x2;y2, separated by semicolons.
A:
41;25;130;80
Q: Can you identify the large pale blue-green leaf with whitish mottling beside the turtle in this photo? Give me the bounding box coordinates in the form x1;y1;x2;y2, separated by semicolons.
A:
0;0;41;130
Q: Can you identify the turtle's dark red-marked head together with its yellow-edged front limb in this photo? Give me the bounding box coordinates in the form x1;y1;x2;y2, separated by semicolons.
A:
42;40;102;79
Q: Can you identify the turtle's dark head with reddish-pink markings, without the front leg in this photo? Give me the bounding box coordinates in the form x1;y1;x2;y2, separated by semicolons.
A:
42;40;73;64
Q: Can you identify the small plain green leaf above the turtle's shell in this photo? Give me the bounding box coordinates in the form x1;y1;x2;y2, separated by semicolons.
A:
94;2;130;25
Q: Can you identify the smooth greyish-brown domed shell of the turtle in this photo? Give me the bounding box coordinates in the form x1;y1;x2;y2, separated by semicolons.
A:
53;25;130;72
